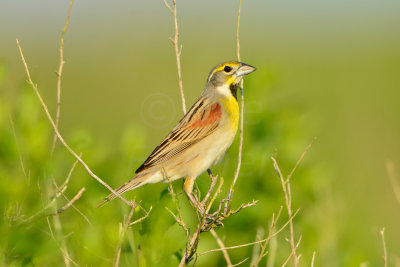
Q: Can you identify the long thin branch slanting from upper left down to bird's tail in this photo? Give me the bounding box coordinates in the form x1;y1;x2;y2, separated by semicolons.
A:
16;39;133;206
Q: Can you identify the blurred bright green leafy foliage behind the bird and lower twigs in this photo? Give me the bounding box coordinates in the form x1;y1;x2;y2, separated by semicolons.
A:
0;57;322;266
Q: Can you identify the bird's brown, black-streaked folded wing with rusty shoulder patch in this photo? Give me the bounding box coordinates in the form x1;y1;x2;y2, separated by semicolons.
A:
136;97;222;173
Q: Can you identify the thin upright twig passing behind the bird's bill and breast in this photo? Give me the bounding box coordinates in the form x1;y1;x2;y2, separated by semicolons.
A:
224;0;244;213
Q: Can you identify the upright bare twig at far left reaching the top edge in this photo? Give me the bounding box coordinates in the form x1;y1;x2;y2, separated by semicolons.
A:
51;0;74;155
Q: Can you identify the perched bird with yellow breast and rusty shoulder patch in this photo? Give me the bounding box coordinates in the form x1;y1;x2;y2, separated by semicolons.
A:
99;61;256;206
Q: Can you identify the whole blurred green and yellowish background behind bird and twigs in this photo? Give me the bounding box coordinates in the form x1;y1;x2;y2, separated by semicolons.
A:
0;0;400;266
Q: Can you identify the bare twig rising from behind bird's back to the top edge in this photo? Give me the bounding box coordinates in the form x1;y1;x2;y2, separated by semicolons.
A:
164;0;186;114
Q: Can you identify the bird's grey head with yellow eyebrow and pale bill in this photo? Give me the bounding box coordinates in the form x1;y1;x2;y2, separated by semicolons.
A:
206;61;256;98
